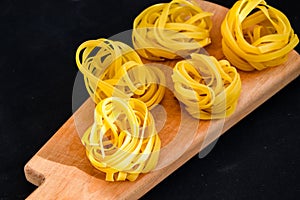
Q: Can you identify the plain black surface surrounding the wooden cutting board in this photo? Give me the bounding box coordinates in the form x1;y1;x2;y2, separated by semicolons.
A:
0;0;300;200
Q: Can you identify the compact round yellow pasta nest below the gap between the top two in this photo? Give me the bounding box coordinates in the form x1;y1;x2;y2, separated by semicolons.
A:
172;54;241;120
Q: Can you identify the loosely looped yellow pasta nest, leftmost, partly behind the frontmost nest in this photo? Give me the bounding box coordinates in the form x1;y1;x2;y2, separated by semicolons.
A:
76;39;165;108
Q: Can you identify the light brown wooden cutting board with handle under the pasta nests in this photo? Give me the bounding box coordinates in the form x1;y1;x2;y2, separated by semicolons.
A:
24;1;300;199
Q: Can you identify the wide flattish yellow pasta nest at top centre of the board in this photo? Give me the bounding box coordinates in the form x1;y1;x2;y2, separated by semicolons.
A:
132;0;212;60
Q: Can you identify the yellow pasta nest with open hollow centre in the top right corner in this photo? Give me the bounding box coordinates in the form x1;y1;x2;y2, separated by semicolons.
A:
221;0;299;71
